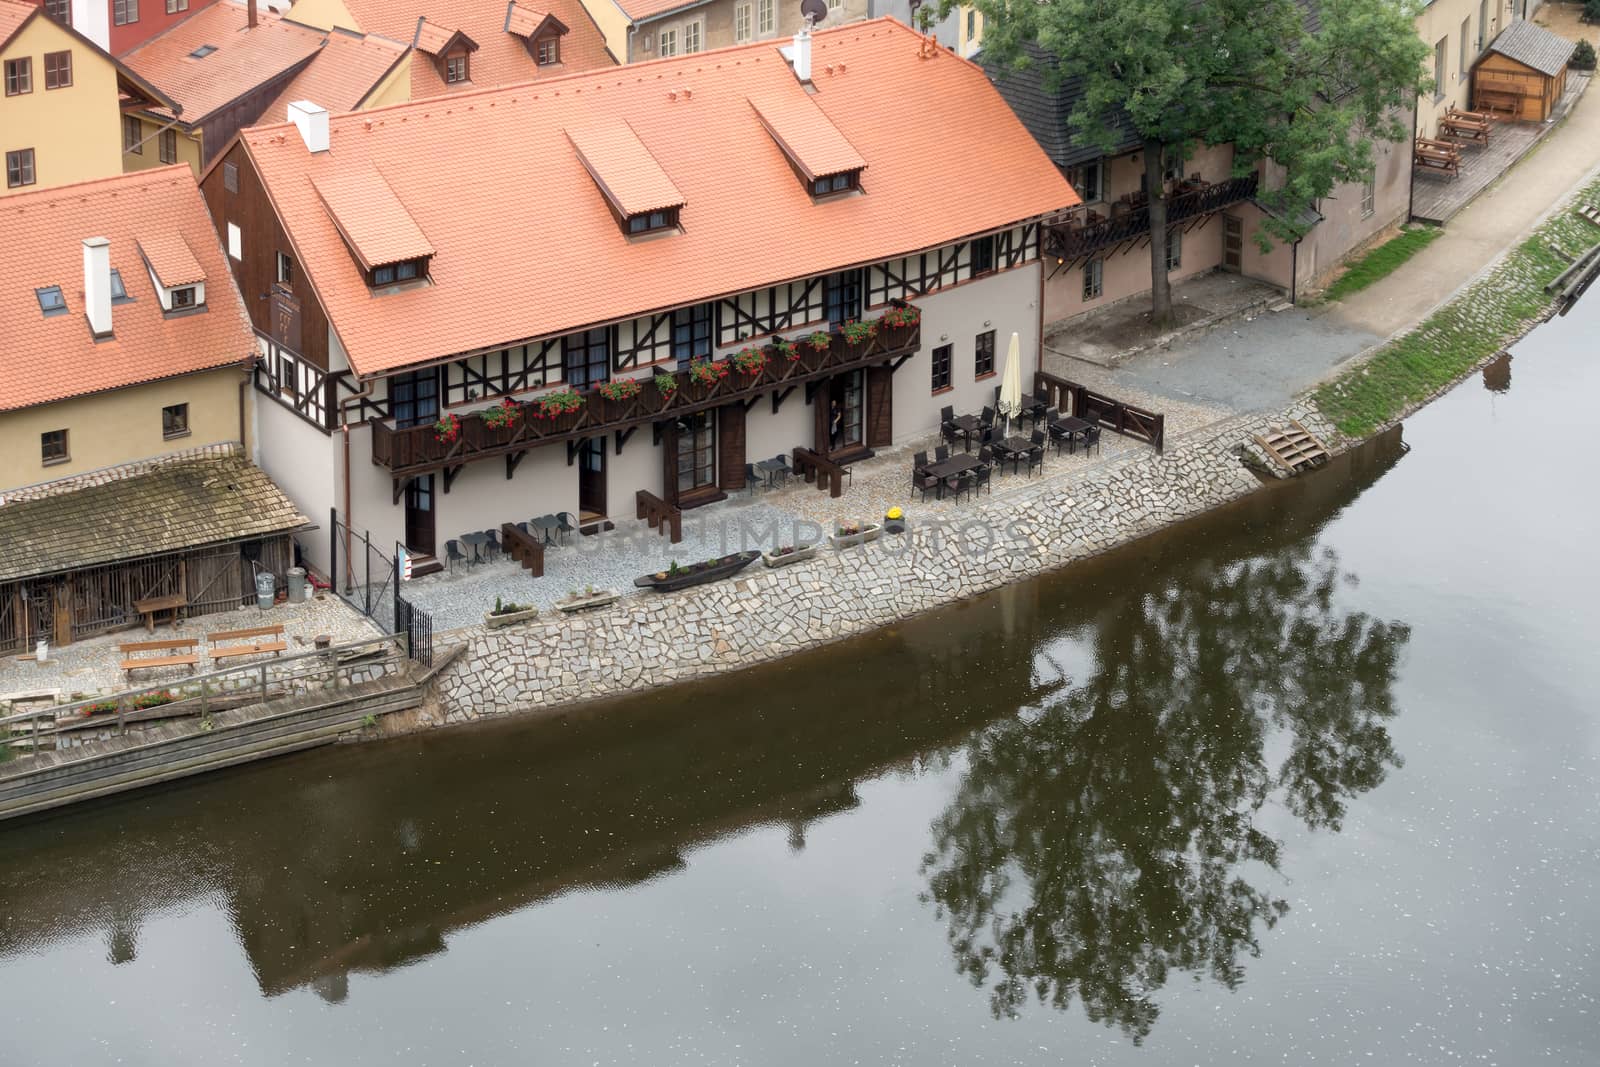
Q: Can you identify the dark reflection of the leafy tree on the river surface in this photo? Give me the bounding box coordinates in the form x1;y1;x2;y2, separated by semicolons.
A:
923;541;1410;1043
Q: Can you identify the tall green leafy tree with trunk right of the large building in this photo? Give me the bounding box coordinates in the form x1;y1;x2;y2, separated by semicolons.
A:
966;0;1429;322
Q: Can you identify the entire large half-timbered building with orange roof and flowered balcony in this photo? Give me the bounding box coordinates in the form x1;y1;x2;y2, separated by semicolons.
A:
202;19;1075;575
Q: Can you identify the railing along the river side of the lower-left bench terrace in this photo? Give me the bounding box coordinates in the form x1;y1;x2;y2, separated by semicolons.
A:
0;633;406;752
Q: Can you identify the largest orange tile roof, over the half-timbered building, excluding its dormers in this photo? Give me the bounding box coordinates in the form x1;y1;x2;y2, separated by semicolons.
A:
243;19;1078;376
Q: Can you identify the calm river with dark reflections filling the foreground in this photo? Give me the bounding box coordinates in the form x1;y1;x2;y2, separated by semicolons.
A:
0;307;1600;1067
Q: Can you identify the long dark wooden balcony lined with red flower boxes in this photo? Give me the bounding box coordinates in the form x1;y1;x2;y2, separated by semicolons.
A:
371;315;922;478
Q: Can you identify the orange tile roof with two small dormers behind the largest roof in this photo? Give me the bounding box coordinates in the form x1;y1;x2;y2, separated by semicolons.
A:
344;0;616;99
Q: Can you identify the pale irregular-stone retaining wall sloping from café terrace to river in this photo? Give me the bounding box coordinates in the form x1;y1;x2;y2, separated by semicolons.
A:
418;402;1331;726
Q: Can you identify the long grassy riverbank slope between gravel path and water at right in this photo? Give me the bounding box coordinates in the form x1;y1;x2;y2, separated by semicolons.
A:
1314;181;1600;437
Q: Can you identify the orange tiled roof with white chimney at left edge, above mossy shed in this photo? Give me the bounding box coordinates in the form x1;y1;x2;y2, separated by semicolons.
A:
0;163;256;410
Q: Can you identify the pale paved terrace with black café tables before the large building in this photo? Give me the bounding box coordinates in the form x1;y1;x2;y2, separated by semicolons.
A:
405;416;1152;632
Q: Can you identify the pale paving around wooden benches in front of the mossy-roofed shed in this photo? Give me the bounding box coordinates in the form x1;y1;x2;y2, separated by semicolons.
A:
0;595;381;713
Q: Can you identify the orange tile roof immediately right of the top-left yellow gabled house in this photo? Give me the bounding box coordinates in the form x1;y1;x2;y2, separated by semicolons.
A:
123;0;325;126
